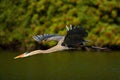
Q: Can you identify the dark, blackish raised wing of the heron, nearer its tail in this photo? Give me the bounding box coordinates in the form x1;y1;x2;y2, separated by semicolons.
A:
62;25;88;47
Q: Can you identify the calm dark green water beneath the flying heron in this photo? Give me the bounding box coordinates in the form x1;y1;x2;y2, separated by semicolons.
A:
0;51;120;80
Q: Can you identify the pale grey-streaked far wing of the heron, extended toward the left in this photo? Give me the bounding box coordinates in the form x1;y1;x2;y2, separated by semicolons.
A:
33;34;64;42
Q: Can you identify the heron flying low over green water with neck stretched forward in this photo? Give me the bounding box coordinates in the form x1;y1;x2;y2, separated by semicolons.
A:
14;25;107;59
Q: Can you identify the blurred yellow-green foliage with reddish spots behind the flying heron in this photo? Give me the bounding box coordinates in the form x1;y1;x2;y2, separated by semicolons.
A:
0;0;120;48
